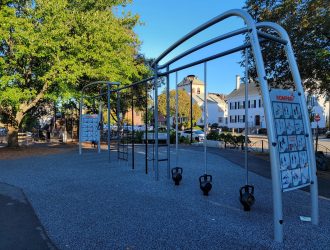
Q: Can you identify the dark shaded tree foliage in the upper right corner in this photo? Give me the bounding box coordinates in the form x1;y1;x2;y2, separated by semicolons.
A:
242;0;330;95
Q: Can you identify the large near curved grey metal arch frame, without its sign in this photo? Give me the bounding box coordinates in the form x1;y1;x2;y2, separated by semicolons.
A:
152;9;318;242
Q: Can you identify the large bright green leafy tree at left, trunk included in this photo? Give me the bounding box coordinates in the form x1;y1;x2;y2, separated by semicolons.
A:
0;0;148;146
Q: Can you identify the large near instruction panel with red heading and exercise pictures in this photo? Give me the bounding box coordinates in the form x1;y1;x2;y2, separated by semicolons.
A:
270;89;313;192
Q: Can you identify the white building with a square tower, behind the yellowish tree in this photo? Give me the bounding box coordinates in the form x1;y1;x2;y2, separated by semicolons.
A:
178;75;228;126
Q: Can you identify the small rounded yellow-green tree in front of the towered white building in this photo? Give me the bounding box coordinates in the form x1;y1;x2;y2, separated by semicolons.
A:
158;90;202;127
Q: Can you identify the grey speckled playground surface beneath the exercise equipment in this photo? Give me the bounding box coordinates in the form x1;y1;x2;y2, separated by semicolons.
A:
0;147;330;249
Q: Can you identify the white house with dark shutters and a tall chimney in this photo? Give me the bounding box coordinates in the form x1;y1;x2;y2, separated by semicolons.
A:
227;76;266;132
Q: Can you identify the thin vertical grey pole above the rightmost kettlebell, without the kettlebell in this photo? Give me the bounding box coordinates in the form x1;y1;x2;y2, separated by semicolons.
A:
244;49;249;185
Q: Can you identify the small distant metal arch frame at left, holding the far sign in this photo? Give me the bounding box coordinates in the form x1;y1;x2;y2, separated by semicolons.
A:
79;81;120;162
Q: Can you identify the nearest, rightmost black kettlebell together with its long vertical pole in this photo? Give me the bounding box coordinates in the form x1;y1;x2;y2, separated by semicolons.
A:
239;48;255;211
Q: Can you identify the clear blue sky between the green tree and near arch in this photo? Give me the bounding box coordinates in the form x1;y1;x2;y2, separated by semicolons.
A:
122;0;244;94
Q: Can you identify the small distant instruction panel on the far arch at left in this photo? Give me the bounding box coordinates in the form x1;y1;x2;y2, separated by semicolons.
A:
81;114;100;142
